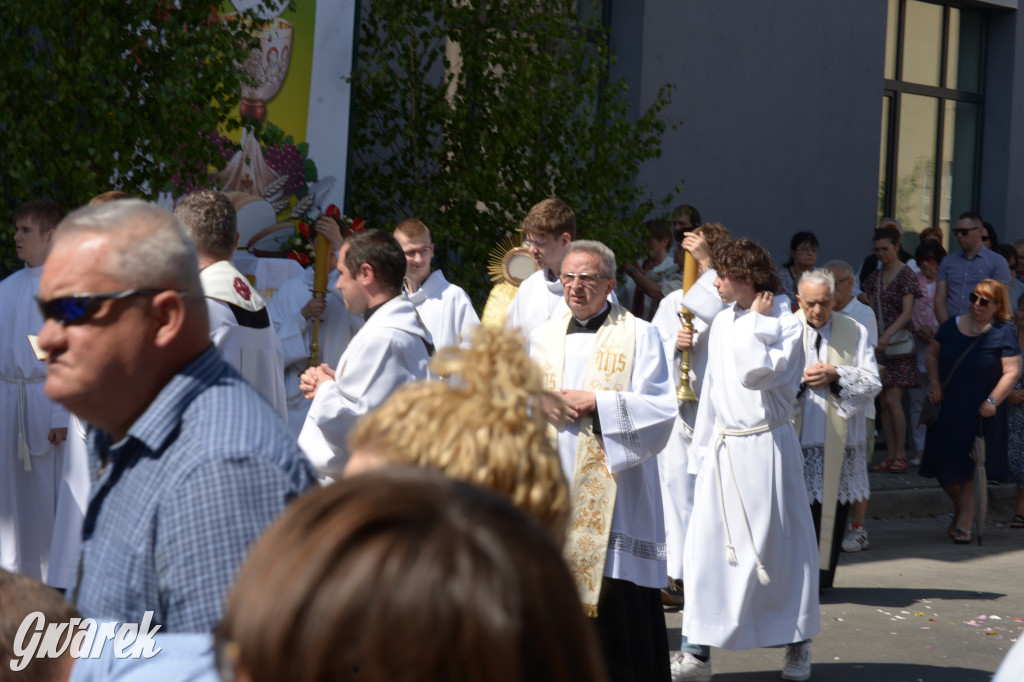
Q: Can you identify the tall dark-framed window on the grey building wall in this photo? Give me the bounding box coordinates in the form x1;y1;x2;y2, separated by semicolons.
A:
879;0;985;241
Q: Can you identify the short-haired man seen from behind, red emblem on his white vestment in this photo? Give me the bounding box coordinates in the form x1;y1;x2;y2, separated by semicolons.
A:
174;189;288;420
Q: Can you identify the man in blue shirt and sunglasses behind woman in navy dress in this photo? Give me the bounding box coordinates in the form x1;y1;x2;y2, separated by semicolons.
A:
935;211;1012;324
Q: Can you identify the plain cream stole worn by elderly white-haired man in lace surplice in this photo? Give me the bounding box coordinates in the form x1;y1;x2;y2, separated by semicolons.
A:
797;310;857;570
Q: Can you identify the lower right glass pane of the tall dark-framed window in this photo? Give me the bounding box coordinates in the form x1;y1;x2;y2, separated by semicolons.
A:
939;100;978;232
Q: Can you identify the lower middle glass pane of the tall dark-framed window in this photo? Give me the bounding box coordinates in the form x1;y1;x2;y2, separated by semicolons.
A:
896;94;939;232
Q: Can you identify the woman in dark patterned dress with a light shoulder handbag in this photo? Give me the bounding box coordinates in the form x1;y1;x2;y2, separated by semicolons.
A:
864;227;922;473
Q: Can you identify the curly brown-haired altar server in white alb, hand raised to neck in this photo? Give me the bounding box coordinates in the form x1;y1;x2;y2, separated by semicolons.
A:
683;239;820;680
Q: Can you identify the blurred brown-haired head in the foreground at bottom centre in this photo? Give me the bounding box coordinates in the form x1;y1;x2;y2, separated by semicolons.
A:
210;467;607;682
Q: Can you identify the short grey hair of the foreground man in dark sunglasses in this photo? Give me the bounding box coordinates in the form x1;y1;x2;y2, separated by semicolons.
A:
54;199;202;292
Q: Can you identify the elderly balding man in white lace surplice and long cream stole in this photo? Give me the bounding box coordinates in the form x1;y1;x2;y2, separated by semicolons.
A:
796;269;882;590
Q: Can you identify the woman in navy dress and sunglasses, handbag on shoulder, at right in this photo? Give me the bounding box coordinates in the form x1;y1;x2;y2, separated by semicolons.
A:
921;280;1021;545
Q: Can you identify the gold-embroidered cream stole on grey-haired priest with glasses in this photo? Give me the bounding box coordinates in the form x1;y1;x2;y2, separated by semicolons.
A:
536;305;636;617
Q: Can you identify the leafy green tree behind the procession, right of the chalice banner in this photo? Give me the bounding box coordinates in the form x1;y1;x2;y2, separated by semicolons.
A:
348;0;672;301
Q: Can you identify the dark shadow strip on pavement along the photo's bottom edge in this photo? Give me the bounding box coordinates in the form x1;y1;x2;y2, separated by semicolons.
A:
715;663;992;682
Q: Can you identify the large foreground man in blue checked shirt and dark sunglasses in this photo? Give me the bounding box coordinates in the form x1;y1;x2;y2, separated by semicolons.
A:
39;200;315;632
